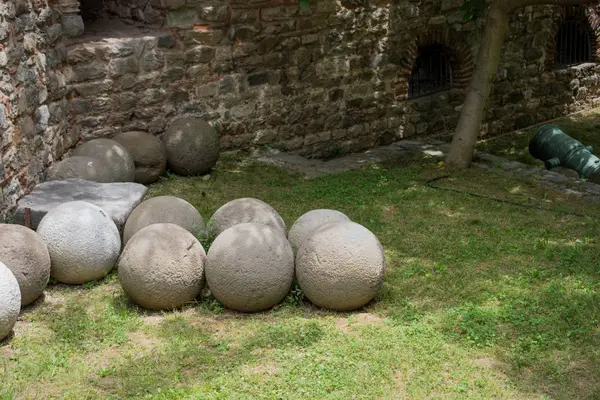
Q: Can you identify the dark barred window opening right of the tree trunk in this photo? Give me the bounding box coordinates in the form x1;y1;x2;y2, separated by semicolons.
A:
554;20;592;68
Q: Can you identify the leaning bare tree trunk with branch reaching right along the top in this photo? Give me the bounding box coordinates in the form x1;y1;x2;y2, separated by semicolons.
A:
446;0;598;168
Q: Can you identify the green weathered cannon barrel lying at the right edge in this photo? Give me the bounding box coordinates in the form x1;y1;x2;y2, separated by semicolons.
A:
529;124;600;183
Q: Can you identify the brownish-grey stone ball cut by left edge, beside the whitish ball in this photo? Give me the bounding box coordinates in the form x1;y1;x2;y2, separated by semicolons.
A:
0;224;50;306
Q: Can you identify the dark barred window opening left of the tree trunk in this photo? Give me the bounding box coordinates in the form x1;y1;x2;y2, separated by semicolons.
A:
408;45;452;98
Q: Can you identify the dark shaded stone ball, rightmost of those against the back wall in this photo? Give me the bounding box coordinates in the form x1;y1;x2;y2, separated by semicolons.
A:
163;117;220;176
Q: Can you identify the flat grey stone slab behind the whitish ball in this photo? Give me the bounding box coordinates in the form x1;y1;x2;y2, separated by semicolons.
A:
15;179;148;231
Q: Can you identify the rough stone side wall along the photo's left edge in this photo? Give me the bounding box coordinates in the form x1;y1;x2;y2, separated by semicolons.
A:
0;0;69;217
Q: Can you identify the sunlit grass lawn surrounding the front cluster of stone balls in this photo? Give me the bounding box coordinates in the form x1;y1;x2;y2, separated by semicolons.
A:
0;148;600;400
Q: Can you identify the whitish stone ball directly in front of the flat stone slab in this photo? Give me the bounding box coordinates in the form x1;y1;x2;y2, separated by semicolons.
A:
37;201;121;284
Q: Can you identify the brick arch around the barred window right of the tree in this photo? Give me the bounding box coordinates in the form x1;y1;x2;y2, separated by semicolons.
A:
545;6;600;71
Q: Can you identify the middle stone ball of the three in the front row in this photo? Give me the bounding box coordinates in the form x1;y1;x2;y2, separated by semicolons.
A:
206;223;294;312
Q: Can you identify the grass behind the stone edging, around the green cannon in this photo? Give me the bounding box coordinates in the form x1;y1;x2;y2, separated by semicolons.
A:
477;108;600;167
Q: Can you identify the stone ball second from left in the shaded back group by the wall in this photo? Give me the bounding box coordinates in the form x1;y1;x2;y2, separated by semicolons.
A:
72;139;135;182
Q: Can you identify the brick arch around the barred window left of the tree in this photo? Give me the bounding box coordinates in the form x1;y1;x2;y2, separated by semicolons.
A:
395;29;474;100
